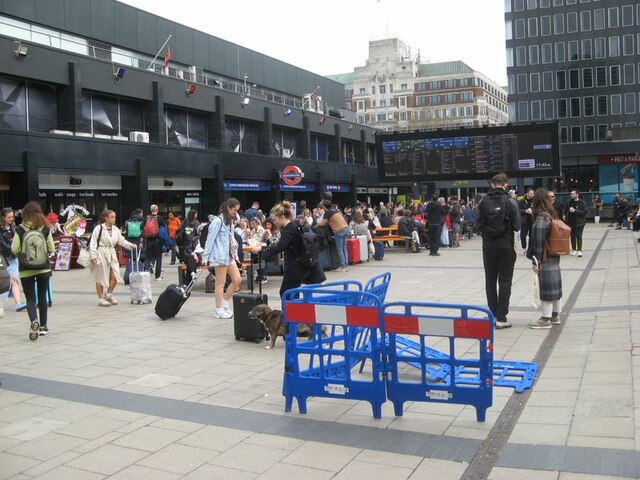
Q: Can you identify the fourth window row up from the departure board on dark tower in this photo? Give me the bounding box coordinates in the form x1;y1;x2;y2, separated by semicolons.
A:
505;4;640;40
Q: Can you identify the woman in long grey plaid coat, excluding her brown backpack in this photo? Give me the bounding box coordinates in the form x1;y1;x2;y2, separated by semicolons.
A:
527;188;562;330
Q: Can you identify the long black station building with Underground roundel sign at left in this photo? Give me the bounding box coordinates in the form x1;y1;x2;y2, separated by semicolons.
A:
0;0;380;220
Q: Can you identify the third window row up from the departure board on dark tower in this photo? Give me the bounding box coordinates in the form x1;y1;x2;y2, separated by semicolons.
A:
507;33;640;67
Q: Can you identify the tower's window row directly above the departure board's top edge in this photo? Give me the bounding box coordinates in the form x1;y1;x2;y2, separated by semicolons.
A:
509;92;640;122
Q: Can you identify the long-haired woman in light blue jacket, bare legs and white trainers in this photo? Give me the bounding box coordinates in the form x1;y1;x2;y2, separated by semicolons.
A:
202;197;242;319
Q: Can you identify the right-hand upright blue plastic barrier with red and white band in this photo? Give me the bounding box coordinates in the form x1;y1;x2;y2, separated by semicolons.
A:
382;302;493;422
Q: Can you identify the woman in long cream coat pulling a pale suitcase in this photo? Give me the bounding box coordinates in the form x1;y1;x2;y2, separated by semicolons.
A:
89;210;138;307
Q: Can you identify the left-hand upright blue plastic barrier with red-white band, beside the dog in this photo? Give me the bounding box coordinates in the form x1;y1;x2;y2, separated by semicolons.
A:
282;285;386;418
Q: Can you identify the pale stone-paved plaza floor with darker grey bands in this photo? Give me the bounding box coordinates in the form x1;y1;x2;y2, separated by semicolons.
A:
0;225;640;480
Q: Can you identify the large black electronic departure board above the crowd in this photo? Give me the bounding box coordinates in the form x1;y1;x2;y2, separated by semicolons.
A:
376;123;560;181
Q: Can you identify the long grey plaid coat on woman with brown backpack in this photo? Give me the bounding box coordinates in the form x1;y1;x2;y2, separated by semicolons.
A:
527;212;562;302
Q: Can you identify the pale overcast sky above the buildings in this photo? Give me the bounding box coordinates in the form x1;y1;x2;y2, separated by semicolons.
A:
120;0;507;85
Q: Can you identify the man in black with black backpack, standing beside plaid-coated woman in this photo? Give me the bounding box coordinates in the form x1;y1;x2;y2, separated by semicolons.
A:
476;172;520;329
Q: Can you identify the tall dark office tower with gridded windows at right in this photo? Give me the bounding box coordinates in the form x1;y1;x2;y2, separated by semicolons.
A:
505;0;640;199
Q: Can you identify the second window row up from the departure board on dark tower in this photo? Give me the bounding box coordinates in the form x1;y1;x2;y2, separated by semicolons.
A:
508;63;640;94
